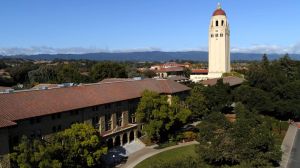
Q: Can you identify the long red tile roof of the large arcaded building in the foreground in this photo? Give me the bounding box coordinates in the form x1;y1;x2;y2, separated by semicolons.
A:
0;79;190;128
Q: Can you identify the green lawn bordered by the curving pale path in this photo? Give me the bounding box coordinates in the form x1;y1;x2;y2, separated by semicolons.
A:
135;145;196;168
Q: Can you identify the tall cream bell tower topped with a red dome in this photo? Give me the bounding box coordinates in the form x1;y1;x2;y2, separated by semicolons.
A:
208;3;230;78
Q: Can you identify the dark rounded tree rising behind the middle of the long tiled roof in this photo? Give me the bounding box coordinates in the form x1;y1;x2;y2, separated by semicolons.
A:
91;62;128;81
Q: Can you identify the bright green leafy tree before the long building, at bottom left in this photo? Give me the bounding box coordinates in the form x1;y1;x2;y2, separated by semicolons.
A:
11;124;107;168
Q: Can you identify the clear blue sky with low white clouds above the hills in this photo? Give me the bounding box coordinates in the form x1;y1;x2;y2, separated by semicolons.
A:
0;0;300;55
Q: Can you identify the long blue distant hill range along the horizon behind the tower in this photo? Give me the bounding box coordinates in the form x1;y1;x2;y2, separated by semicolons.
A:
0;51;300;61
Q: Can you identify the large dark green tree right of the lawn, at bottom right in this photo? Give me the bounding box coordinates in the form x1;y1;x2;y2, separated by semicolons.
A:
198;103;281;167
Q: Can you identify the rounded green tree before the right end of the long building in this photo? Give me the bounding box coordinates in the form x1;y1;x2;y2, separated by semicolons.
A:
136;90;191;141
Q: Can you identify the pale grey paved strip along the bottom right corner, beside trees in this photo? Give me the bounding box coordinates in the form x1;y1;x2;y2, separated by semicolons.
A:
280;124;298;168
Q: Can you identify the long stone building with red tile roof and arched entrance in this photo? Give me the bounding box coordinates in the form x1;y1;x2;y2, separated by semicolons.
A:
0;79;190;167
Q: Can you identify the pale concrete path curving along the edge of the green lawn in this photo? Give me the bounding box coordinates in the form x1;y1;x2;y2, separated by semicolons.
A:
118;141;198;168
